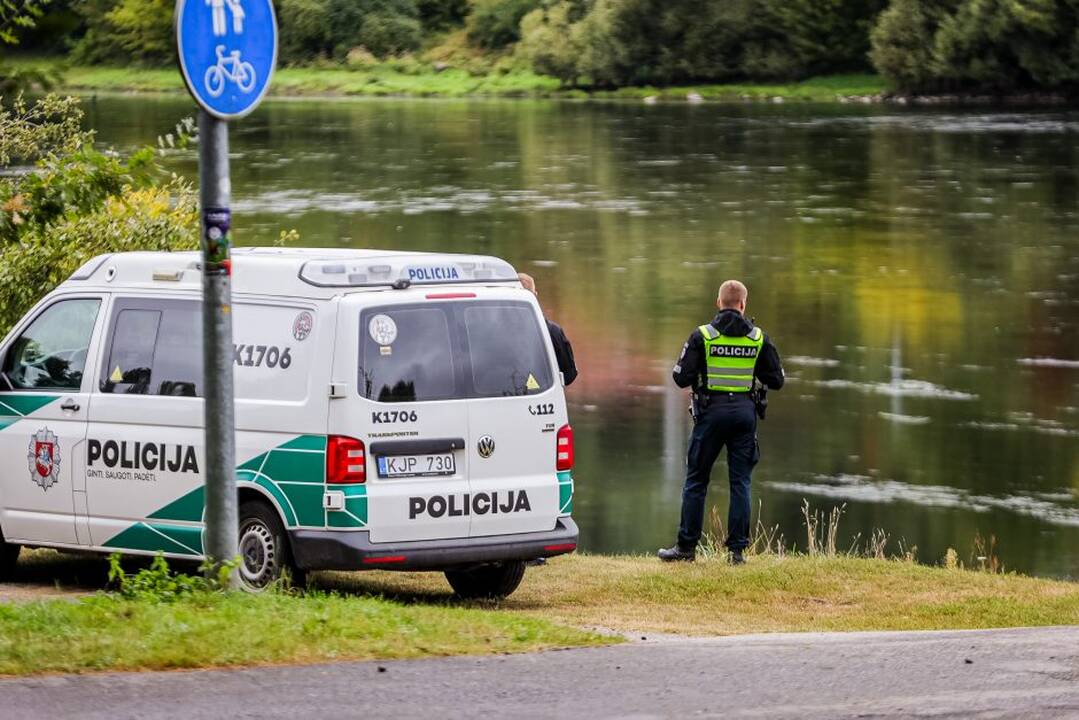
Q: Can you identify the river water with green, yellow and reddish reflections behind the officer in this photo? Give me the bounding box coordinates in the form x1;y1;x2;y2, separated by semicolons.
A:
90;97;1079;576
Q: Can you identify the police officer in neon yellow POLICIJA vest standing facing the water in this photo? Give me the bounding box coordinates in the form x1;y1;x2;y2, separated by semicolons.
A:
658;280;783;565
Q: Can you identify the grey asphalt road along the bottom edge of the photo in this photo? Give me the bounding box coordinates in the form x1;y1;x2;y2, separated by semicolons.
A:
8;627;1079;720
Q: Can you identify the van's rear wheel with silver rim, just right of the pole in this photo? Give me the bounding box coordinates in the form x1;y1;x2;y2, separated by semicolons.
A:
238;501;302;593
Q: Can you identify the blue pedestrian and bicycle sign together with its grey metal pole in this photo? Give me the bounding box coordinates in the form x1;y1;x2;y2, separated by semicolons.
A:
174;0;277;588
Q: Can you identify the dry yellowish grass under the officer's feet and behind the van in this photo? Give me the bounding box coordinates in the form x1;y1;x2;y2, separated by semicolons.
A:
315;554;1079;636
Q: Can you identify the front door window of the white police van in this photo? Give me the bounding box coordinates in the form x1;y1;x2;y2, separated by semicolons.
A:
3;298;101;391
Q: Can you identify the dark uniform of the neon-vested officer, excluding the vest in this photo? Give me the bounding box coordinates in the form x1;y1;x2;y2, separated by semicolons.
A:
660;309;783;559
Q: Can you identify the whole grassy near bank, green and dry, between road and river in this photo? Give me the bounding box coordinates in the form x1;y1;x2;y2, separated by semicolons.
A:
0;551;1079;675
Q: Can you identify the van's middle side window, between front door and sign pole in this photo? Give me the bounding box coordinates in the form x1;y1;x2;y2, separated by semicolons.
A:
99;298;203;397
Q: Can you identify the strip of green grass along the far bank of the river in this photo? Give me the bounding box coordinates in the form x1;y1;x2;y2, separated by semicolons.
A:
18;59;886;101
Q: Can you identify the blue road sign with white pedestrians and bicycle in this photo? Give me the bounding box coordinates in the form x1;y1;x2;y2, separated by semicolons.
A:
176;0;277;120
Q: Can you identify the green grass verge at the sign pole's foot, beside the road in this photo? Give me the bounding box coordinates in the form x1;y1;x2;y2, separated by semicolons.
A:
0;593;604;675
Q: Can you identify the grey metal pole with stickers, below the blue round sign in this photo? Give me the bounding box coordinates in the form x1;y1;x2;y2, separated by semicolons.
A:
199;110;238;588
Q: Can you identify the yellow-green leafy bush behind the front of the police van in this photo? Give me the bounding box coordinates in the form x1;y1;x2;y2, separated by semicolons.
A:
0;97;197;327
